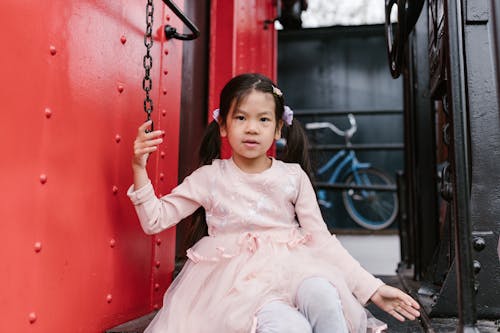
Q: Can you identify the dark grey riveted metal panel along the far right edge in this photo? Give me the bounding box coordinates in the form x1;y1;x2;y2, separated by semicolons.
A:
459;0;500;324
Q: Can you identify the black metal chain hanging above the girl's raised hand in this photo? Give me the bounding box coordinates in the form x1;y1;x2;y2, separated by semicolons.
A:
142;0;155;132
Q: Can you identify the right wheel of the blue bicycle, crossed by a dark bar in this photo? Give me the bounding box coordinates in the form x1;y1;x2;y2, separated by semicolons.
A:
342;168;398;230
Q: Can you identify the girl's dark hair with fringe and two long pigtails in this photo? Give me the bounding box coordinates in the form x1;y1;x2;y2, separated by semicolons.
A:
187;73;312;247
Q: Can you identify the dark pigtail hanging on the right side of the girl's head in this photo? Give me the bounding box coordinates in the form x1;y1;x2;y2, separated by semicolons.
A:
280;119;313;181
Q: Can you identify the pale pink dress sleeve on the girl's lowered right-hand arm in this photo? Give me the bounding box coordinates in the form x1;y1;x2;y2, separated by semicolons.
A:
295;169;384;304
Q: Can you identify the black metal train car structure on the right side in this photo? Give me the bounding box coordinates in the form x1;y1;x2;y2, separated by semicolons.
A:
386;0;500;332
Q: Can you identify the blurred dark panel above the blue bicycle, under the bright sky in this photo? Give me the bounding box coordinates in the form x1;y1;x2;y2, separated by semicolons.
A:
278;25;403;110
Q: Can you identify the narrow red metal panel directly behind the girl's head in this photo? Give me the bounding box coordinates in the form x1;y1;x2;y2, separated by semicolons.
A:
209;0;277;157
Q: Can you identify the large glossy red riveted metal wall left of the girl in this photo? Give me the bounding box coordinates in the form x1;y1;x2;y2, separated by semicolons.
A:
0;0;183;332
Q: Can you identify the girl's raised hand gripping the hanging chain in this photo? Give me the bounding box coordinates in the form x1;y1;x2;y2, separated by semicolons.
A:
132;120;164;169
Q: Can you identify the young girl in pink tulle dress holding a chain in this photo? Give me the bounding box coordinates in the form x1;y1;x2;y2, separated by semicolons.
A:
128;74;419;333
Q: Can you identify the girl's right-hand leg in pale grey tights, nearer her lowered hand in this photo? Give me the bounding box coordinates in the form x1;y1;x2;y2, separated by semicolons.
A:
297;277;348;333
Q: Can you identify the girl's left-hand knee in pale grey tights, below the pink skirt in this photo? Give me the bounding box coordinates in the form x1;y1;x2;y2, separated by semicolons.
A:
257;301;312;333
